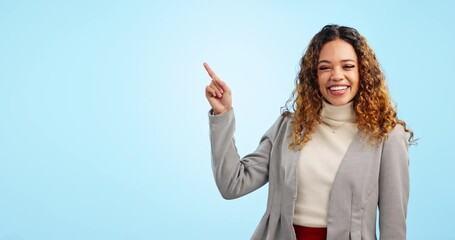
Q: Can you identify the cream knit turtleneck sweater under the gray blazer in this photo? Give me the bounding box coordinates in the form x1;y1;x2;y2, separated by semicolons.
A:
294;101;357;227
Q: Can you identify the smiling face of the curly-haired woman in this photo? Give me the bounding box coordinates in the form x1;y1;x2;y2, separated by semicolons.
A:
317;39;359;105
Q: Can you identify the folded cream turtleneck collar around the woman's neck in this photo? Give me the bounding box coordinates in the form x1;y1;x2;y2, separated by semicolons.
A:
321;100;356;123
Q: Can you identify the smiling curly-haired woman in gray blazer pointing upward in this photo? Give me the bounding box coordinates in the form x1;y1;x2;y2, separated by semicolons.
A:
204;25;413;240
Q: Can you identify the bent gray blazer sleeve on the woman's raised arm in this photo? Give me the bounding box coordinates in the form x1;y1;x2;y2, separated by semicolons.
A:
209;110;283;199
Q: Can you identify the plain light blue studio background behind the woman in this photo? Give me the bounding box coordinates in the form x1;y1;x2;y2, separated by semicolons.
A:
0;0;455;240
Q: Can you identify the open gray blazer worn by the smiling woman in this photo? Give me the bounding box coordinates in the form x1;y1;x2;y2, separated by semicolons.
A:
209;111;409;240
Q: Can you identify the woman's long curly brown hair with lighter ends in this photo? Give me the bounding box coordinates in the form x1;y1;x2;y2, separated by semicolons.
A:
282;25;414;150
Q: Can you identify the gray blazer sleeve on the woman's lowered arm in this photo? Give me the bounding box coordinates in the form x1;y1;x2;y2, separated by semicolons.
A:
378;125;409;240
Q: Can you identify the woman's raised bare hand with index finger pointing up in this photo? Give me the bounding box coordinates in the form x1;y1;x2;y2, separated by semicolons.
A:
204;63;232;115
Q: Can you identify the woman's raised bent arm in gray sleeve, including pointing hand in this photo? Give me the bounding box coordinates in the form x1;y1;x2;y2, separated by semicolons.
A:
204;63;280;199
